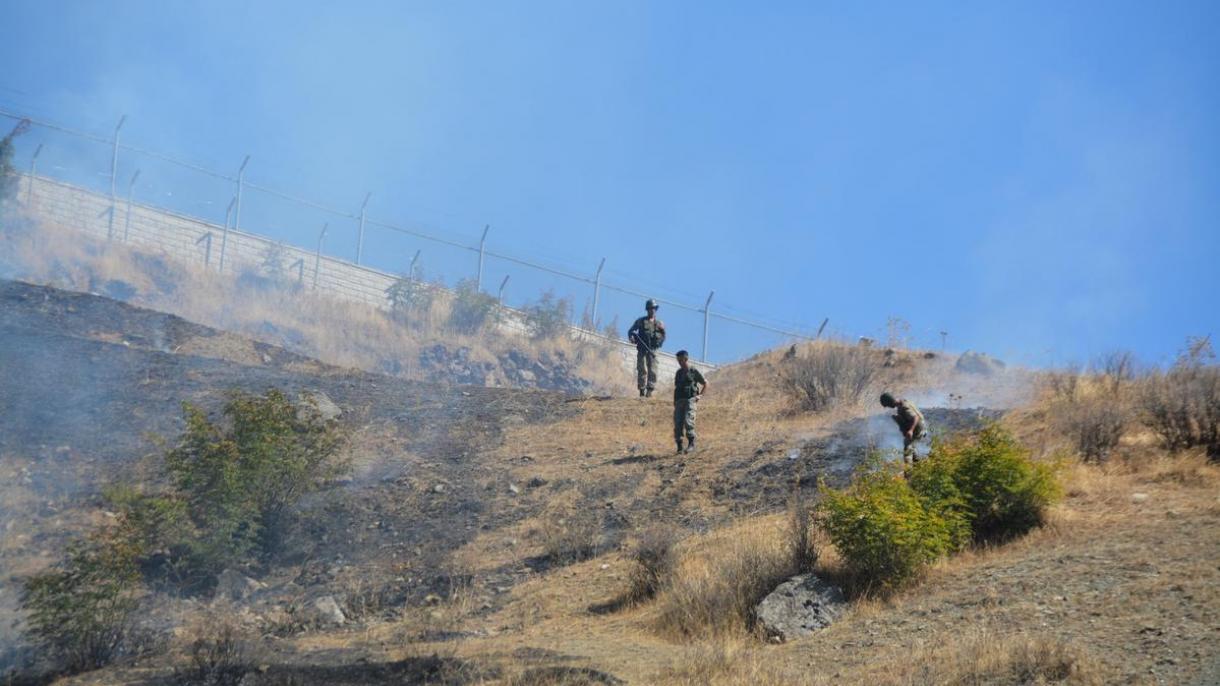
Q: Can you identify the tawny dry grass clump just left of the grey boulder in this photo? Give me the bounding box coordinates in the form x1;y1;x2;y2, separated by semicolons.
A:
658;525;797;637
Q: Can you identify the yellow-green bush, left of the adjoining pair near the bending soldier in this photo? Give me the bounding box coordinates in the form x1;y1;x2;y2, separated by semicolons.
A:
819;468;959;591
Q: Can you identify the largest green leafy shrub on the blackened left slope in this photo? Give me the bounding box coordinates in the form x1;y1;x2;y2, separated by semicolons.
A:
111;389;344;582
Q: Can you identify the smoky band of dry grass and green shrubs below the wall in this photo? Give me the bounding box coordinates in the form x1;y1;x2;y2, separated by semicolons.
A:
0;220;626;393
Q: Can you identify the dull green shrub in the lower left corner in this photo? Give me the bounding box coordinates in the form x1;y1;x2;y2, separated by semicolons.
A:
22;535;139;671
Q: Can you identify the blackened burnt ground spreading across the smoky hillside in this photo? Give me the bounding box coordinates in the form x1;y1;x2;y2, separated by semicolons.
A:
0;282;1015;684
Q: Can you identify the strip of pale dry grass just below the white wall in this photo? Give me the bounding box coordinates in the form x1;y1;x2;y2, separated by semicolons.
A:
2;218;628;392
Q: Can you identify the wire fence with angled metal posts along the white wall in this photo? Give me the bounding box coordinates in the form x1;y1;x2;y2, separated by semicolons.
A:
0;109;826;361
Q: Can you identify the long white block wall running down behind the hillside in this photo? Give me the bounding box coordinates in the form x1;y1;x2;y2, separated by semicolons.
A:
18;175;711;378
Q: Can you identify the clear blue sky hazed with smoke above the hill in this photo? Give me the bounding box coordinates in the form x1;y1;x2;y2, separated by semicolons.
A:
0;1;1220;364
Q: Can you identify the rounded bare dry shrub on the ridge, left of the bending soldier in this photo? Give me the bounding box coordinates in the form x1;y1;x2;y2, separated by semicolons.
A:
781;342;877;411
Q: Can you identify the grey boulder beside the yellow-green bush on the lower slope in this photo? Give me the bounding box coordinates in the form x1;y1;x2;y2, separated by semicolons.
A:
754;574;847;641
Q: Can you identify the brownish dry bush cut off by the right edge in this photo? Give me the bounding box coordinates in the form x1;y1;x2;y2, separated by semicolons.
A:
1137;338;1220;460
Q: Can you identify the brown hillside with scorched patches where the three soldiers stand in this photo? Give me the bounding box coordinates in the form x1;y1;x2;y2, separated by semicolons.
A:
0;282;1220;685
